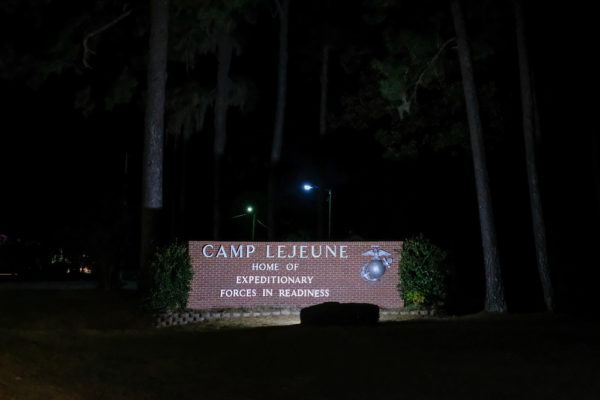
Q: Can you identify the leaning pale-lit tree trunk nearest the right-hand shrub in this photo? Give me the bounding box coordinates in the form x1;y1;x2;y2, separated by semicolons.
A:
450;0;506;312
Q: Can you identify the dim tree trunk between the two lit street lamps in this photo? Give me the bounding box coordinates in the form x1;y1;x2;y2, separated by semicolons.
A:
268;0;290;240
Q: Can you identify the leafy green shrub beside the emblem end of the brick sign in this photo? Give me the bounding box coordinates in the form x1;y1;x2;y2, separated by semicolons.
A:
398;234;448;305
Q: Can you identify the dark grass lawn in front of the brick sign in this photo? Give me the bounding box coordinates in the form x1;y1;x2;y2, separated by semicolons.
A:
0;290;600;400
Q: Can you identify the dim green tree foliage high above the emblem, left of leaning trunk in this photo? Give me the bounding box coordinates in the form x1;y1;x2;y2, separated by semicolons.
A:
360;0;468;162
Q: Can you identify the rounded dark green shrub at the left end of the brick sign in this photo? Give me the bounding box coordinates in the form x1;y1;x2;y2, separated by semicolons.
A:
147;243;193;311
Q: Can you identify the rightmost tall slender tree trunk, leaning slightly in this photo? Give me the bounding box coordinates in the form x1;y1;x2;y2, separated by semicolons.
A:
515;0;555;312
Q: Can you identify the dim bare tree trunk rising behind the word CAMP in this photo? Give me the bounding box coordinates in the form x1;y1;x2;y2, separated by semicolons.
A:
213;26;233;240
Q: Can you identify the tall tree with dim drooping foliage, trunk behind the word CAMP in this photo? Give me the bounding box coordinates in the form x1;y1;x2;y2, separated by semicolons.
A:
169;0;263;239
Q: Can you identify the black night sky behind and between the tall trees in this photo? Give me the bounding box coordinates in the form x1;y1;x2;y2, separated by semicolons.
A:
0;0;600;305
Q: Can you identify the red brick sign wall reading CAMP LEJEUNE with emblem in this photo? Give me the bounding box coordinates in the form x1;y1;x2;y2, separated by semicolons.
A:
188;241;403;309
